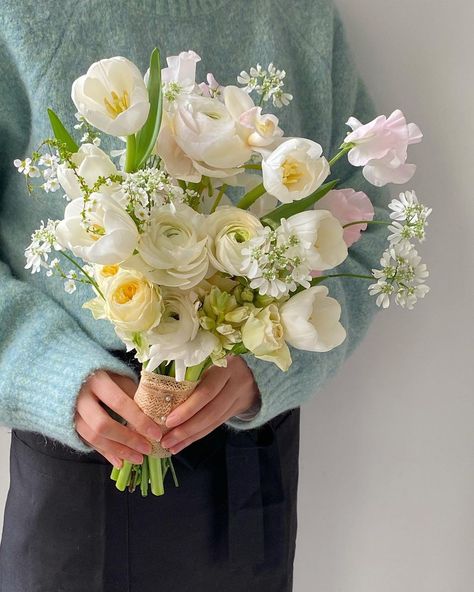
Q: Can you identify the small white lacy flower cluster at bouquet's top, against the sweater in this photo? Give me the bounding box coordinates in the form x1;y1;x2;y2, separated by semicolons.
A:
237;63;293;107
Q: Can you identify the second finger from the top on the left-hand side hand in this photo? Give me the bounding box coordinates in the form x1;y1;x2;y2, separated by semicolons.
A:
77;386;151;454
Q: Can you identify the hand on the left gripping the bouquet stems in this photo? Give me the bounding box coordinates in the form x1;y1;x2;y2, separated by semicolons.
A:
75;370;162;467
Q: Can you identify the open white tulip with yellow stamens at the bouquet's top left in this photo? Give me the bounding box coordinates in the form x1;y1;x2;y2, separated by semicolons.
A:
71;57;150;136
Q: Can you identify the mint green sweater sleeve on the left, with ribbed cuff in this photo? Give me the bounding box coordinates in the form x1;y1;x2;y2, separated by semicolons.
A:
0;40;139;452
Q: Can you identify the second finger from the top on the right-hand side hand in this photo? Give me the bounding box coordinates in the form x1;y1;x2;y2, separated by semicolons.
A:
161;388;235;449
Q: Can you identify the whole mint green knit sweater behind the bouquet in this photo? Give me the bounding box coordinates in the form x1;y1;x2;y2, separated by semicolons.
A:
0;0;387;451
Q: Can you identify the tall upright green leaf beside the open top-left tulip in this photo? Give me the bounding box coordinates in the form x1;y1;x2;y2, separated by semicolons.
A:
136;47;163;168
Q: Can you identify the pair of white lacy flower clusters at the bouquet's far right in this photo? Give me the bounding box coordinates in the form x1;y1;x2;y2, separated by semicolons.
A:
369;191;431;310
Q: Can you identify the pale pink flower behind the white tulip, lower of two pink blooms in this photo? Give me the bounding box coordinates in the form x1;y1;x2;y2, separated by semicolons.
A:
314;189;374;247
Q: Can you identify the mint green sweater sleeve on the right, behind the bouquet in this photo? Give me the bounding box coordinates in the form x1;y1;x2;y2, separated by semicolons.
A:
226;10;388;430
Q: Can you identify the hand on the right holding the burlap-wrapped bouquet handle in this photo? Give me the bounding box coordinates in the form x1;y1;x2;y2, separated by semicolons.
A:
161;356;260;454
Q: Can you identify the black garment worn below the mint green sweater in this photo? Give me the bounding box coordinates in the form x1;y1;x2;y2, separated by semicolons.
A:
0;382;300;592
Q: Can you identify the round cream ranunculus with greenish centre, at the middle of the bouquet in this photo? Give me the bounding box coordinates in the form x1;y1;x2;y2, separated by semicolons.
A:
206;206;263;276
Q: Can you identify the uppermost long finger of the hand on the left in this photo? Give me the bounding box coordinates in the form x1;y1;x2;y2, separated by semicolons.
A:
90;372;162;440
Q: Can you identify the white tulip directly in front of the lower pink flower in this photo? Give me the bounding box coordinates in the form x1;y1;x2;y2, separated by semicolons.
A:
282;210;348;271
